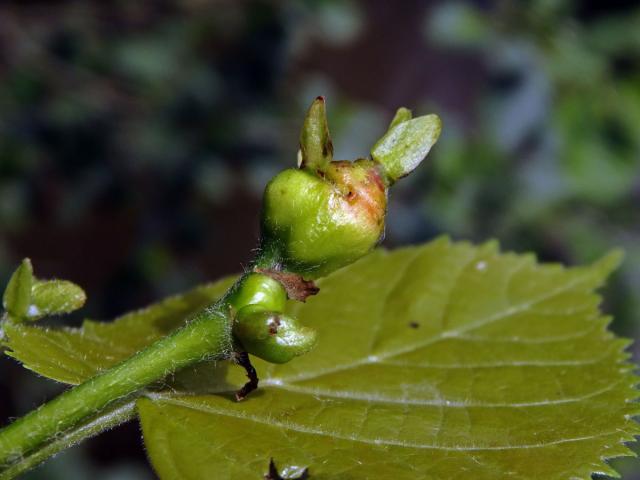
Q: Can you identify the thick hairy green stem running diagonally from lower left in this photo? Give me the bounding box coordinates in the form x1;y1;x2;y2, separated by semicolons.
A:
0;300;233;470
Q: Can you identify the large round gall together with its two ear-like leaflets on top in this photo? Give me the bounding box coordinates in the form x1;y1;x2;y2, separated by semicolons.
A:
261;97;441;279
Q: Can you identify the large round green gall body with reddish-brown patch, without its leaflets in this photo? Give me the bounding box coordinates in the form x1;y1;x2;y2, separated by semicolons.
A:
262;160;387;278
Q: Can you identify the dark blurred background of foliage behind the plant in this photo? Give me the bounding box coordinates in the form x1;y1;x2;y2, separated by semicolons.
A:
0;0;640;480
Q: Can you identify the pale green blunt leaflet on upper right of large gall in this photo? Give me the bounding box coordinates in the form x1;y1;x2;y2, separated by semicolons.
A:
371;109;442;182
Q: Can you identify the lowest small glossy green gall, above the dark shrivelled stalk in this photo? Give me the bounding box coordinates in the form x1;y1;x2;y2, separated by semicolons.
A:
233;306;316;363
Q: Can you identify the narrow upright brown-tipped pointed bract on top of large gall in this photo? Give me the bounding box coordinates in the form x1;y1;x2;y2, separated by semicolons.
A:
299;97;333;171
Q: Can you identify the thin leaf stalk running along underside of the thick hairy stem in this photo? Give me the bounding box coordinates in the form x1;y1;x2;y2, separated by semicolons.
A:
0;400;136;480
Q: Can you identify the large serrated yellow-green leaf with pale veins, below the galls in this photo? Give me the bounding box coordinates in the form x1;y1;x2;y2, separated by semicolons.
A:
138;239;640;480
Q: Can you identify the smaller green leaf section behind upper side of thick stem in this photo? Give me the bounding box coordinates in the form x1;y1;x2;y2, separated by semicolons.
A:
3;278;234;385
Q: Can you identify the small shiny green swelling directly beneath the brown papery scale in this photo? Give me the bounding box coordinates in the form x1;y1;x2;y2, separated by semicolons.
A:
227;273;287;312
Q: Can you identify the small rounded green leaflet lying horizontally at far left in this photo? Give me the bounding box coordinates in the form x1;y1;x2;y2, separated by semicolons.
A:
27;280;87;320
